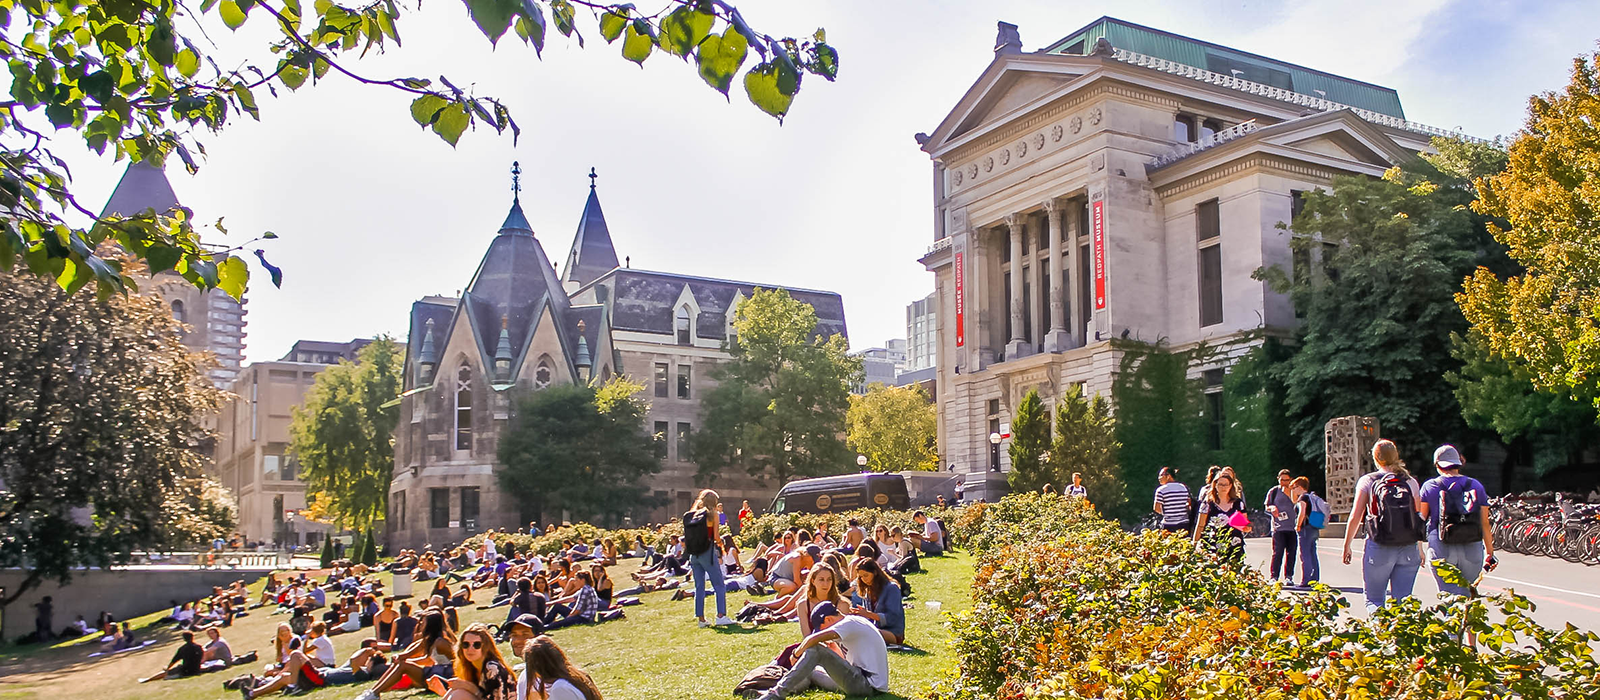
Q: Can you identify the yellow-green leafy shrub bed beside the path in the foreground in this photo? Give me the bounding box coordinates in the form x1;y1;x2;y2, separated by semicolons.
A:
933;494;1600;700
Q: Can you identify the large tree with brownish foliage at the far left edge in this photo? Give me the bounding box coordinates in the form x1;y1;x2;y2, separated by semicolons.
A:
0;265;230;606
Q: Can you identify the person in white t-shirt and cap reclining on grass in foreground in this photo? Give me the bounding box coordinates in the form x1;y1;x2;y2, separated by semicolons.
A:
748;603;890;700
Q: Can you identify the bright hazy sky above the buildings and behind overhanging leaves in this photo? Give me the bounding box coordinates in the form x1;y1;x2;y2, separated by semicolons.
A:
74;0;1600;361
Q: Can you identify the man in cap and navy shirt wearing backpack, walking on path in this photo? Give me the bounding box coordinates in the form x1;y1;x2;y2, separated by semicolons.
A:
1421;444;1494;596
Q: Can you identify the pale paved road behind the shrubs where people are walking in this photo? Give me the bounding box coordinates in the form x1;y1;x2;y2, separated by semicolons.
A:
1245;539;1600;631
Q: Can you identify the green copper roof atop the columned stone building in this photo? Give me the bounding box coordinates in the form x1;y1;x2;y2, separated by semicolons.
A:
1042;18;1405;118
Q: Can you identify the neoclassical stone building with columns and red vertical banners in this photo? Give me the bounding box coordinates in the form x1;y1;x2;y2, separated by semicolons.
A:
917;18;1465;499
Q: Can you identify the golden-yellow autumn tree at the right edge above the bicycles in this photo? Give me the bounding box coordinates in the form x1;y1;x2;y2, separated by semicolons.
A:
1456;53;1600;406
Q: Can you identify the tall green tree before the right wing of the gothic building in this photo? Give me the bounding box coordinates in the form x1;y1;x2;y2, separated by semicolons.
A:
691;289;861;483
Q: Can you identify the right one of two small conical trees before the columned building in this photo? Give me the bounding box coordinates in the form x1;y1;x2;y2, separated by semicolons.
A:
1046;384;1128;515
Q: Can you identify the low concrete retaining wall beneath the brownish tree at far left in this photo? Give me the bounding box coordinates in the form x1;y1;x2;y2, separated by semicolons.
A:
0;569;267;641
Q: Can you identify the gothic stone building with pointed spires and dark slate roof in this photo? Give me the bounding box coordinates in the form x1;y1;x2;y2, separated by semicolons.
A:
387;177;845;547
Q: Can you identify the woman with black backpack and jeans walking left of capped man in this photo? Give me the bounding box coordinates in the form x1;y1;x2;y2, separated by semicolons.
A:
1344;439;1422;612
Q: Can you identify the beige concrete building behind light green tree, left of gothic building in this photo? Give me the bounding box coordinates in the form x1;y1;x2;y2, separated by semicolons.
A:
213;339;371;545
